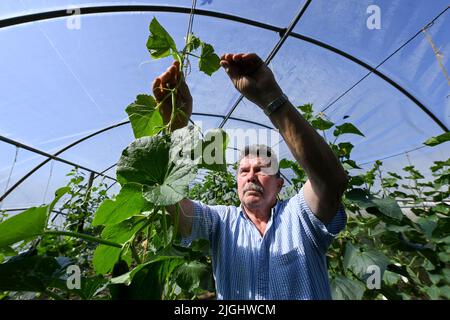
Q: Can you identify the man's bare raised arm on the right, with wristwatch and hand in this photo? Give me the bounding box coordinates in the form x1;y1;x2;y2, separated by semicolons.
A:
220;53;347;223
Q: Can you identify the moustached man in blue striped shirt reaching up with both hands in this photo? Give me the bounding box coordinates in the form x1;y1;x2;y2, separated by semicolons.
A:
153;54;347;299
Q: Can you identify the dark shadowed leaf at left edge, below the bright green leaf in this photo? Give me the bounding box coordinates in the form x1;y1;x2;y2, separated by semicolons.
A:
0;253;72;292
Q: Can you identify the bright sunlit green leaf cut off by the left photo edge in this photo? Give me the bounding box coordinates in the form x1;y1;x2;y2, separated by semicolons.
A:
0;206;48;248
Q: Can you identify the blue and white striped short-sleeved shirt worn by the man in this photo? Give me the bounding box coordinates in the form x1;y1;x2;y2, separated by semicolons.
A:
182;188;347;300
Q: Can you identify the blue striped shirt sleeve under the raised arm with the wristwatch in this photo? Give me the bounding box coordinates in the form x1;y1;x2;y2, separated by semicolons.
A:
294;188;347;253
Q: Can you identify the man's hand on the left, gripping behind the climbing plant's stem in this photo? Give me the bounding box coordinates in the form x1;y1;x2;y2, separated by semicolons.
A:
152;61;192;131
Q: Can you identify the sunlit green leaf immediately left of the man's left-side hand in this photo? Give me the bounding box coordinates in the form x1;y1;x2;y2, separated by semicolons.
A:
126;94;163;138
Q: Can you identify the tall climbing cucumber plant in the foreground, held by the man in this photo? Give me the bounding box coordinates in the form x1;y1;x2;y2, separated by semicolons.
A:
0;18;227;299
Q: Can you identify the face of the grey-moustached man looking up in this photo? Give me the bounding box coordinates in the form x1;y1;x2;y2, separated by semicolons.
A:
237;156;283;209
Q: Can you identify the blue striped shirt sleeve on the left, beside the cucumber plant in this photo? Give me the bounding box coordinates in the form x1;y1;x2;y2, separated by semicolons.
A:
181;201;222;247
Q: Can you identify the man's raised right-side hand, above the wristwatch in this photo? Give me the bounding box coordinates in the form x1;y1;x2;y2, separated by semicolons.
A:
220;53;283;108
